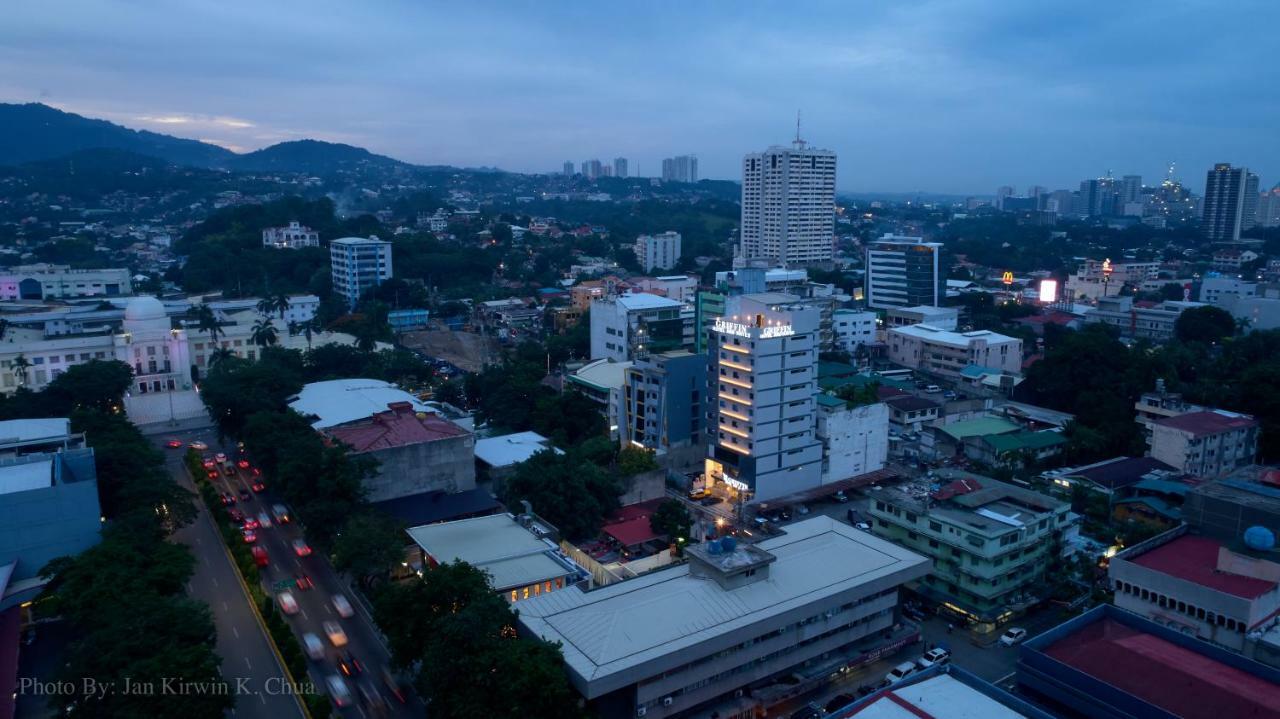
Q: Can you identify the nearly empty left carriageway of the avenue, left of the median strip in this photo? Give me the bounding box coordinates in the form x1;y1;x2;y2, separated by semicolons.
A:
164;430;305;719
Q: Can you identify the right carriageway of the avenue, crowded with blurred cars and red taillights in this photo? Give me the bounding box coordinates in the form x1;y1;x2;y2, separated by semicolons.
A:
169;427;425;718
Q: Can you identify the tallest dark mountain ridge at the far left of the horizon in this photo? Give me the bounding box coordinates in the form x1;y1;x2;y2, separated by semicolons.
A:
0;102;236;168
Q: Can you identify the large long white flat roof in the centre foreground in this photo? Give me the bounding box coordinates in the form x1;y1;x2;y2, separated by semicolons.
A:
520;517;928;699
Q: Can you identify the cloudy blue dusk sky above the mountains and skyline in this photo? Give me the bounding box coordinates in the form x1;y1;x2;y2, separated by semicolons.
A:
0;0;1280;194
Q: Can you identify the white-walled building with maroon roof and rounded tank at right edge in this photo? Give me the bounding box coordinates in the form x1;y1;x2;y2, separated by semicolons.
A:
1107;527;1280;656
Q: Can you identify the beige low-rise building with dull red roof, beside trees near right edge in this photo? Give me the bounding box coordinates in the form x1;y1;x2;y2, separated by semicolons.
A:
1151;409;1258;477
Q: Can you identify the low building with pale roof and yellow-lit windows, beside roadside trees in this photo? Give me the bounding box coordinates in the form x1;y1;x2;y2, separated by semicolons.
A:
406;514;588;604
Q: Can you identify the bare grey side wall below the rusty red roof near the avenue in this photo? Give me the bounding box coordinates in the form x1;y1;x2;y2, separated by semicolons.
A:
365;434;476;502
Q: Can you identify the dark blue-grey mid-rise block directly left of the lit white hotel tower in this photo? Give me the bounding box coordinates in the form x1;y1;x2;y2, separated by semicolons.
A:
620;349;708;457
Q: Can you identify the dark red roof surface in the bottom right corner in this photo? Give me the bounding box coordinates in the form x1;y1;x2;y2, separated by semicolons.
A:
1044;616;1280;719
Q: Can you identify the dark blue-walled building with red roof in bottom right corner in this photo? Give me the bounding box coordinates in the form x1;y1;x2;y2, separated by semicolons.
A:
1018;604;1280;719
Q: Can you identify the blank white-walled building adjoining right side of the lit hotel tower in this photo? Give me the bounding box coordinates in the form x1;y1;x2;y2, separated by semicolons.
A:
815;394;890;484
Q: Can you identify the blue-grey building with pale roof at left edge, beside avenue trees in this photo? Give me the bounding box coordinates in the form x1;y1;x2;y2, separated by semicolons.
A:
0;417;102;609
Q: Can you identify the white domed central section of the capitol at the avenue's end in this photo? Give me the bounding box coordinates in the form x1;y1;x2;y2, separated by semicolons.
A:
113;296;192;394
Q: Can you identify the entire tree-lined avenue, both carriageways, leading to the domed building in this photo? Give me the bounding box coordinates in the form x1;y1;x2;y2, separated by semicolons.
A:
157;431;424;718
